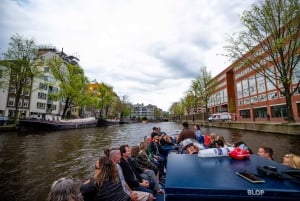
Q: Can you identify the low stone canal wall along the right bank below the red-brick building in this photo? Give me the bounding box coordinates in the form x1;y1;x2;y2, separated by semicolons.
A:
186;120;300;136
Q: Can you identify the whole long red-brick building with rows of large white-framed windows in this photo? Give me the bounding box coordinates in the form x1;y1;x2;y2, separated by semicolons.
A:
208;41;300;122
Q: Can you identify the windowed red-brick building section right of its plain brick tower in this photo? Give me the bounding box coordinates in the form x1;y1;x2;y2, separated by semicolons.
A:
234;57;300;121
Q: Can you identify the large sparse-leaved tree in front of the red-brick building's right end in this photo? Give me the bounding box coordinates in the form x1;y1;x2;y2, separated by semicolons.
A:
225;0;300;122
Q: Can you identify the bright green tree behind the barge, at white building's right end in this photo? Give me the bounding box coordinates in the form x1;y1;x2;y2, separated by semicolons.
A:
47;57;89;119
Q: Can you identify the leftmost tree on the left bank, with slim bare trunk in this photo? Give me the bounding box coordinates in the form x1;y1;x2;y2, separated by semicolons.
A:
0;34;42;120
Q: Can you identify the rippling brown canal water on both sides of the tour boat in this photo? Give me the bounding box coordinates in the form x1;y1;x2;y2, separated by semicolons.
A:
0;122;300;201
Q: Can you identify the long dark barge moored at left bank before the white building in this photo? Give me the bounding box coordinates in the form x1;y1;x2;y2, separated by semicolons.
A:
18;117;98;131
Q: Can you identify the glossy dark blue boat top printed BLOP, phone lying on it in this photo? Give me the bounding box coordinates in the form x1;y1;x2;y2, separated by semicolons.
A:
164;154;300;201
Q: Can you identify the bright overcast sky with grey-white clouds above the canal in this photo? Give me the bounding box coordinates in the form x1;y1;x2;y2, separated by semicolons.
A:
0;0;255;111
